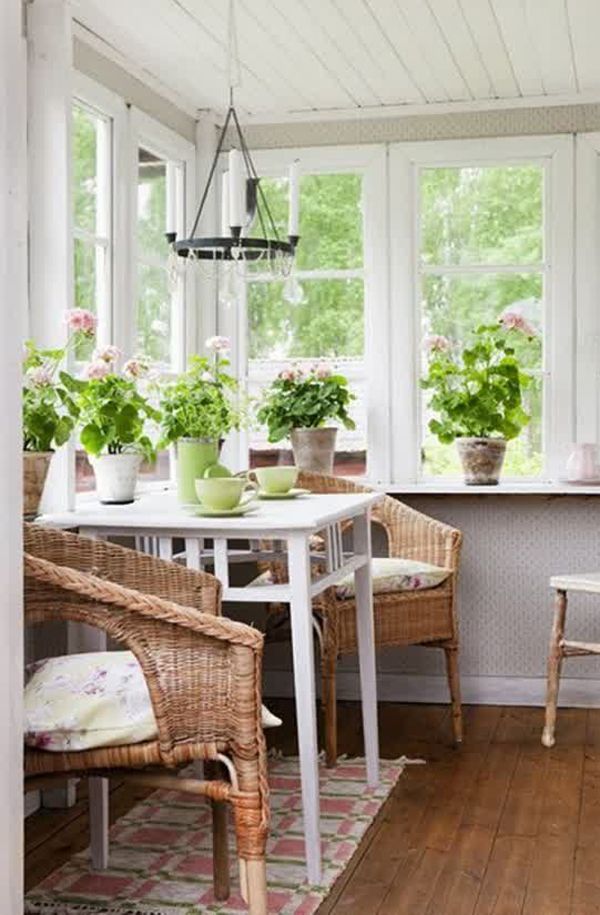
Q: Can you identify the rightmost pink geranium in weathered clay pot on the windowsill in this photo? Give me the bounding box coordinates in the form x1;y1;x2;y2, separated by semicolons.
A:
421;311;536;486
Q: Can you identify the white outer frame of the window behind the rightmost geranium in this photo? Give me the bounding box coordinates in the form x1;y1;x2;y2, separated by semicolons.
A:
389;135;575;484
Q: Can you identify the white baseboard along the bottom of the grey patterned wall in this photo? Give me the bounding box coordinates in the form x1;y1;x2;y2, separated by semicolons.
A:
264;670;600;708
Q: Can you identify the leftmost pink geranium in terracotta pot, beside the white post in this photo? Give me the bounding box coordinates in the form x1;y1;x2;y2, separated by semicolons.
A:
23;308;96;517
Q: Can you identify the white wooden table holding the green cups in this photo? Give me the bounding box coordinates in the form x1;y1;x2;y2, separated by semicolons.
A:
37;491;381;884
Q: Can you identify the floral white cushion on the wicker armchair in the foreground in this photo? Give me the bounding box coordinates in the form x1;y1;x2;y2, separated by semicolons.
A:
24;651;281;752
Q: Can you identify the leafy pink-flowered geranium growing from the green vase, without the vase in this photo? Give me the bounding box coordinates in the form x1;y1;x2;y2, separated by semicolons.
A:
160;337;241;445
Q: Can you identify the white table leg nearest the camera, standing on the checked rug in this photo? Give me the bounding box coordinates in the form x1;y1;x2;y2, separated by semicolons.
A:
288;535;321;884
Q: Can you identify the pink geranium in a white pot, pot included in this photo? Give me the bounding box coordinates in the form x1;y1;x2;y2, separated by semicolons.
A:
71;346;160;505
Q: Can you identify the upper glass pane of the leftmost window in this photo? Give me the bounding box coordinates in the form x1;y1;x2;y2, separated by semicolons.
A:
71;105;100;233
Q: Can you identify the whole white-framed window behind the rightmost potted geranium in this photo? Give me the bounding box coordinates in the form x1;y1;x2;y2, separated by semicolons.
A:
389;136;575;484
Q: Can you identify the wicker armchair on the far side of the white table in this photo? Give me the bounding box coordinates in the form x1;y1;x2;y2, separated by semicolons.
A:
264;471;462;766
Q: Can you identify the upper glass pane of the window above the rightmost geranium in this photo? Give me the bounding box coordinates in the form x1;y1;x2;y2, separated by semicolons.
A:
420;165;544;265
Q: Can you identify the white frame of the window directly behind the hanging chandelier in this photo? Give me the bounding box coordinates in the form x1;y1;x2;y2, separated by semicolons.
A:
218;145;390;481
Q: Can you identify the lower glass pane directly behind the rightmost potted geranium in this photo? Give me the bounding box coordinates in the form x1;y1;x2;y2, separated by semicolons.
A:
421;274;543;477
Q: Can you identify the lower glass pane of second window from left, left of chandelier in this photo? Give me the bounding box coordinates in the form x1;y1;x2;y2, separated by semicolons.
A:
136;264;171;366
